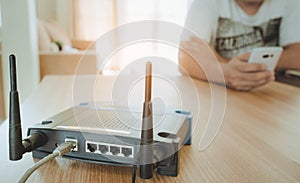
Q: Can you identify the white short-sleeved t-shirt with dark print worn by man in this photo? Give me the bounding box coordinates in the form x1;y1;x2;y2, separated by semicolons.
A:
185;0;300;58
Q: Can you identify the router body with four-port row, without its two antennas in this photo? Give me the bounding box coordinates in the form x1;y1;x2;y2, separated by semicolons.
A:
28;106;191;176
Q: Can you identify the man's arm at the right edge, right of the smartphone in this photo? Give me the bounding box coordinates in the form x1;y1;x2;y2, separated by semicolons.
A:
276;43;300;70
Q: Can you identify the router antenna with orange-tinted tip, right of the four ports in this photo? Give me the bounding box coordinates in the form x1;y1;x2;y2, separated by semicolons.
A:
140;62;153;179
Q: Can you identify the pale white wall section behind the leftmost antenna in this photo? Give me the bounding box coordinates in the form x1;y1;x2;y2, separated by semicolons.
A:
1;0;40;114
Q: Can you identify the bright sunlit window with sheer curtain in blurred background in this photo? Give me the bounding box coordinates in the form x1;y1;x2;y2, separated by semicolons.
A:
73;0;190;71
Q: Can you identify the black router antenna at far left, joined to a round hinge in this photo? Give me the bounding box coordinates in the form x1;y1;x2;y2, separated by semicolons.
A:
9;55;24;160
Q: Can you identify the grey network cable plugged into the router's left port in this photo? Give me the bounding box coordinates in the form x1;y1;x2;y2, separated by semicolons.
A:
19;142;75;183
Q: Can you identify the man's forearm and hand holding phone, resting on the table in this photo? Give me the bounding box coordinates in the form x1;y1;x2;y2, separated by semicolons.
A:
178;38;274;91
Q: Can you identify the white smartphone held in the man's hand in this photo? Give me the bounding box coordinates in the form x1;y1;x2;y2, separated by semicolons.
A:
248;47;282;70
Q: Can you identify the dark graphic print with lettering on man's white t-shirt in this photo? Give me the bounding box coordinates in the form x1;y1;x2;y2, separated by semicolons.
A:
215;17;281;58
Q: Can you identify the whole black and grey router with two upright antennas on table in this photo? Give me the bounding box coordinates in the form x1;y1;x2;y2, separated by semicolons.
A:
9;56;192;179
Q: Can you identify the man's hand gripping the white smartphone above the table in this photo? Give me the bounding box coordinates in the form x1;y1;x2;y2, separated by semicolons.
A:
222;53;275;91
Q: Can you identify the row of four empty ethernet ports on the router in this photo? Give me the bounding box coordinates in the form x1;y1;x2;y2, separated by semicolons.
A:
86;142;134;158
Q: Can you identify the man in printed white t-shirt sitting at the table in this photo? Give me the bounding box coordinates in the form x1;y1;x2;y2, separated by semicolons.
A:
179;0;300;91
